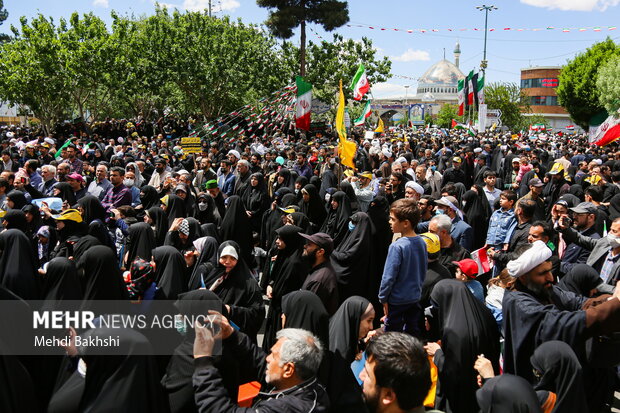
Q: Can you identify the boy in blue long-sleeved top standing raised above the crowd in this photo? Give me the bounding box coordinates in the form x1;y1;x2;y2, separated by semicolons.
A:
379;199;428;336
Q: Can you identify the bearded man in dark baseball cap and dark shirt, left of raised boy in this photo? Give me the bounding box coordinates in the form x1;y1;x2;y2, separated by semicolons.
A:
299;232;339;317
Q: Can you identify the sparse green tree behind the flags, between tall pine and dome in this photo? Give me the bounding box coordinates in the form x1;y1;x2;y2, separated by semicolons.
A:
283;34;392;105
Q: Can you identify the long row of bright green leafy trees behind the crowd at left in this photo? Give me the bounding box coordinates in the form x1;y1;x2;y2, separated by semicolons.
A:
0;7;293;130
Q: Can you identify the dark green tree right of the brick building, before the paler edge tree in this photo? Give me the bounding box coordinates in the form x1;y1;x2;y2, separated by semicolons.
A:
557;38;620;130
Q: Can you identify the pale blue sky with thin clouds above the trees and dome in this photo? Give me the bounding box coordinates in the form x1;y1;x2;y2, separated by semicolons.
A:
0;0;620;98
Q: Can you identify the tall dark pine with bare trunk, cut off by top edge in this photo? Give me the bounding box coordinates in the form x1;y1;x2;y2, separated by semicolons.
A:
256;0;349;76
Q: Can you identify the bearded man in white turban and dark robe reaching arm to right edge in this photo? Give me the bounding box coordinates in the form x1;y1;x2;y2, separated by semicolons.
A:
502;241;620;411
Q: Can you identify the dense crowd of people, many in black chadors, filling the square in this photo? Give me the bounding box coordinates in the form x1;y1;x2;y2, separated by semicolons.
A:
0;118;620;413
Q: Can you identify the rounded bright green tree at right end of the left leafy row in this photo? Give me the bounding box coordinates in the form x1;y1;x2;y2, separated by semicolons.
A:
148;9;290;118
